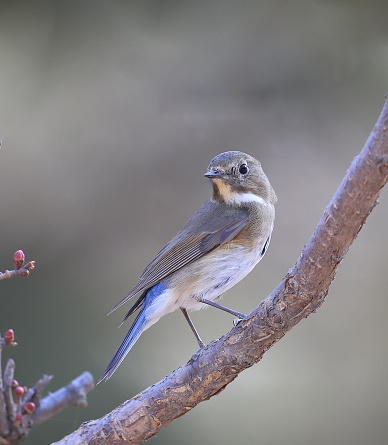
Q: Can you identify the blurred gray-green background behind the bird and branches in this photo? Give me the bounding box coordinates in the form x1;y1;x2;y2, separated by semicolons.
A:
0;0;388;445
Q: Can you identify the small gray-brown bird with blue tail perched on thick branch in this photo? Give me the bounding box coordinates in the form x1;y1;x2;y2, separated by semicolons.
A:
98;151;277;383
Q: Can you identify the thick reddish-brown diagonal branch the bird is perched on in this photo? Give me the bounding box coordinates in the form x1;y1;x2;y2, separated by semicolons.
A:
56;98;388;445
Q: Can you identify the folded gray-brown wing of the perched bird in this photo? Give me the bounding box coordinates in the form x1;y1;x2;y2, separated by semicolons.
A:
109;212;248;314
